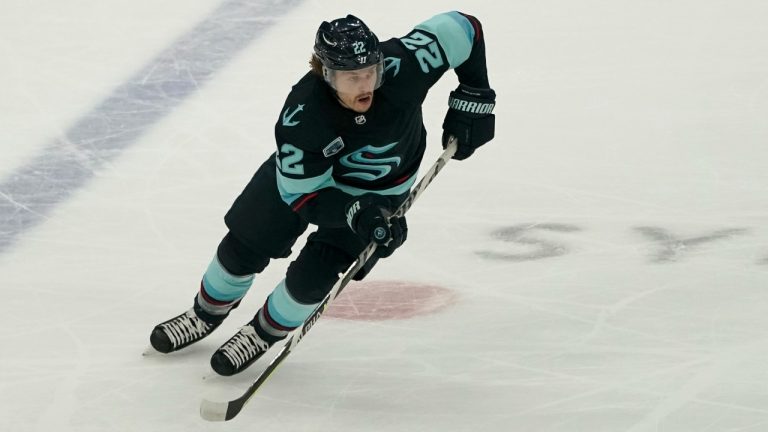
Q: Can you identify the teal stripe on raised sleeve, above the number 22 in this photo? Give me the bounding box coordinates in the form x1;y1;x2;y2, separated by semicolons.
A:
416;11;475;68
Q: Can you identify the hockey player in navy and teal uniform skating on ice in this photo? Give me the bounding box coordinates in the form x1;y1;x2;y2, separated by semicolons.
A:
150;12;496;375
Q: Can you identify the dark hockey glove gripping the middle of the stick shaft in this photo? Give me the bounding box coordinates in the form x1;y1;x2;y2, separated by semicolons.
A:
347;194;408;258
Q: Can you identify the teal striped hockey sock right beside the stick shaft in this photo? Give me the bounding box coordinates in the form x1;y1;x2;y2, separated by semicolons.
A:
256;279;319;343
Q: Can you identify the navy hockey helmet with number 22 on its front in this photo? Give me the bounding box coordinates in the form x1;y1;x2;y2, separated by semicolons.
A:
315;15;383;70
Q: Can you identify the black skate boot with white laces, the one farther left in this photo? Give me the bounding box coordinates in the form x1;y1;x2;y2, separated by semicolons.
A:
149;296;229;354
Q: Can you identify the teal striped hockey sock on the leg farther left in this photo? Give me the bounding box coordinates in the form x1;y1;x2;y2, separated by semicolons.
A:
197;256;254;315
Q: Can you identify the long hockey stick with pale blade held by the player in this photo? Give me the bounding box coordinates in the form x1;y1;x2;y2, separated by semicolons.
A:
200;137;456;421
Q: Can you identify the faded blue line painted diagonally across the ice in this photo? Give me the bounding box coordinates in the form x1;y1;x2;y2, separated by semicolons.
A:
0;0;301;254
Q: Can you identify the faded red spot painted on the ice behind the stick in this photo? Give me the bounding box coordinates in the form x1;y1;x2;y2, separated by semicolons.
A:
325;281;456;321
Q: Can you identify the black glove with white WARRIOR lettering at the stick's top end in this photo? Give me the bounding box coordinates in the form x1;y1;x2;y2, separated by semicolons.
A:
443;84;496;160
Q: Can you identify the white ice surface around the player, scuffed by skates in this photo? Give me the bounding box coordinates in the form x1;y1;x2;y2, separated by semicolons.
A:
0;0;768;432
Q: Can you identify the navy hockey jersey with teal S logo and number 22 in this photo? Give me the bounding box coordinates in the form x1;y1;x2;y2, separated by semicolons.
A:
275;12;489;227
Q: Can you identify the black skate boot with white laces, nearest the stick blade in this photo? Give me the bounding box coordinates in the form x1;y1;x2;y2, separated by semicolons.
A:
211;318;285;376
